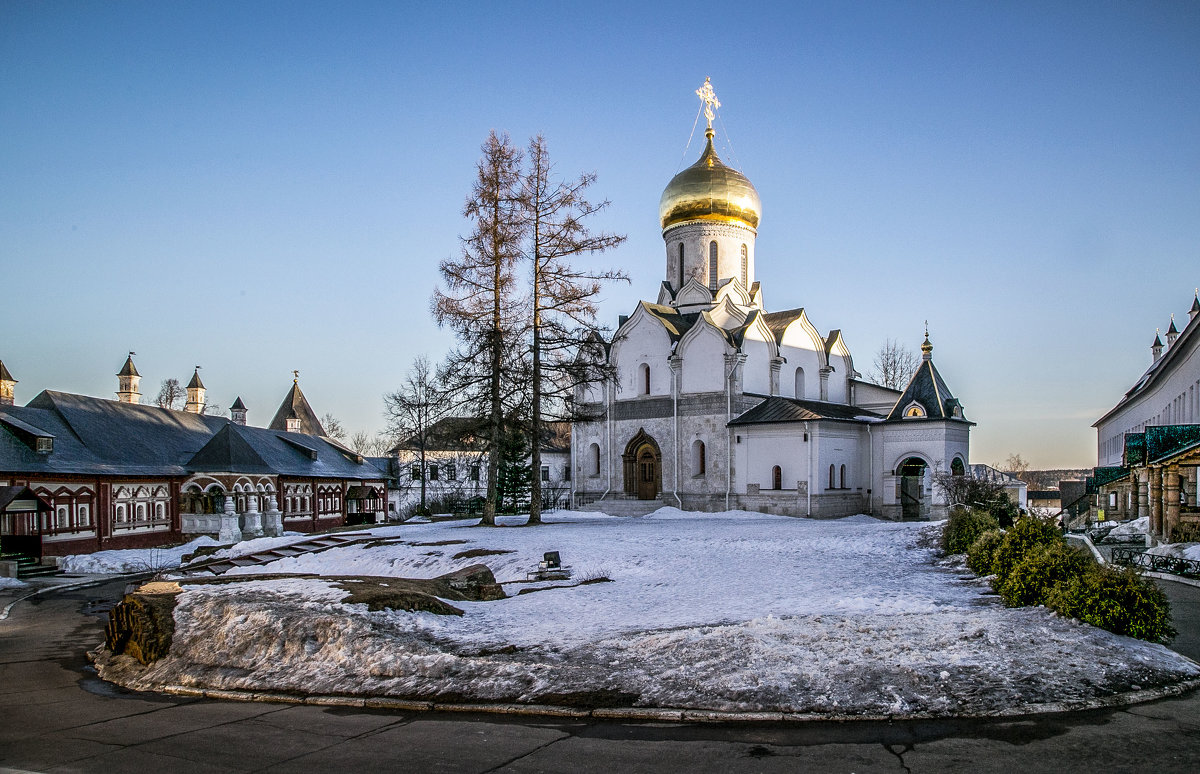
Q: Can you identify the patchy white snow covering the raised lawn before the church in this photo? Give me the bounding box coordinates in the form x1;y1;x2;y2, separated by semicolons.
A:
102;509;1200;715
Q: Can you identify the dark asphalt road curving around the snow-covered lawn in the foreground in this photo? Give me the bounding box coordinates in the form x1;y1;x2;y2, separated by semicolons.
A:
0;583;1200;774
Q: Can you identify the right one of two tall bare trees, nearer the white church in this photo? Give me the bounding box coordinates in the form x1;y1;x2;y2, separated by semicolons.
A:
522;134;629;524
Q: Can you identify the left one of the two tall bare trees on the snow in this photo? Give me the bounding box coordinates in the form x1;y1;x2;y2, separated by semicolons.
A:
432;132;526;524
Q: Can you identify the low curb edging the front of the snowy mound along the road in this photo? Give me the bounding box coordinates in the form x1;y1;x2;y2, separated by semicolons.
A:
160;678;1200;724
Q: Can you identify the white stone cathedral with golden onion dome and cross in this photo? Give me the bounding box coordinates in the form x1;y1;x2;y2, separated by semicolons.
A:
571;80;973;520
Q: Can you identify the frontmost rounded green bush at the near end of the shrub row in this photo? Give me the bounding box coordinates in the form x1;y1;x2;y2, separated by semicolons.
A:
1045;564;1176;642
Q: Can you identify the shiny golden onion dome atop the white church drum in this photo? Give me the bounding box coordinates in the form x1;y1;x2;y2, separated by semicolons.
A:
659;130;762;230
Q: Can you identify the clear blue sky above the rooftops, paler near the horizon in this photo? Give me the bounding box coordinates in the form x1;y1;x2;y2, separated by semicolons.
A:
0;0;1200;467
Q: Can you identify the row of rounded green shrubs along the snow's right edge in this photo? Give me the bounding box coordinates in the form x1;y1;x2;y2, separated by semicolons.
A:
942;512;1175;642
